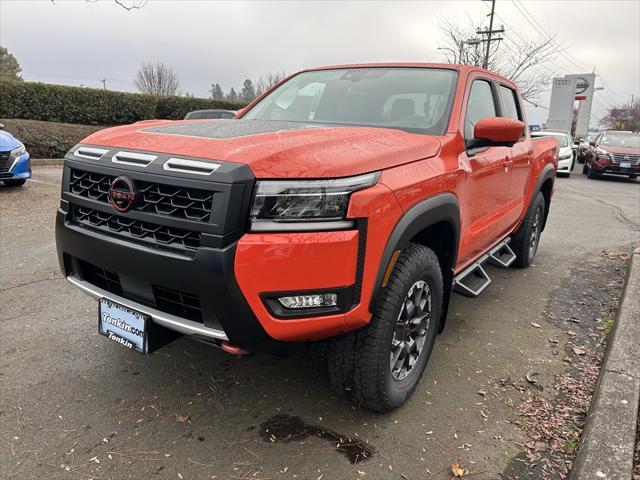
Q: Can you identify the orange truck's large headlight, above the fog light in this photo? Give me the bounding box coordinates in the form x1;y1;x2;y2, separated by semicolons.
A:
251;172;380;232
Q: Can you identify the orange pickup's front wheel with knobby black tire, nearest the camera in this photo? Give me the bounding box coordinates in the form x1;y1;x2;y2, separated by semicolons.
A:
329;243;443;412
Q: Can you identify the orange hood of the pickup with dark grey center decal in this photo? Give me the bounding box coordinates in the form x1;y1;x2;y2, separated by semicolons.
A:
82;119;440;178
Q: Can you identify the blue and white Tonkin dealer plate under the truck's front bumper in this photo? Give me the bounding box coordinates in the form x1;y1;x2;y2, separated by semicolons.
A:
98;298;149;353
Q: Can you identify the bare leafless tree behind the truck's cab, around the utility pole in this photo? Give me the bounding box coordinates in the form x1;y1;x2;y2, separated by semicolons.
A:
440;18;558;101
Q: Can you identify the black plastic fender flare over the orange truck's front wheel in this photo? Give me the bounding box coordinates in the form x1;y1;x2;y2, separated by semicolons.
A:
369;193;460;312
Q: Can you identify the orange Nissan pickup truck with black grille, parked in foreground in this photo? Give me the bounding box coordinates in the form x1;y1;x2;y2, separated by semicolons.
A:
56;63;557;411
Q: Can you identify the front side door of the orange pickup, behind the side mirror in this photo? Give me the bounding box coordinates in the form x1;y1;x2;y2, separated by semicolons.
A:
459;78;511;262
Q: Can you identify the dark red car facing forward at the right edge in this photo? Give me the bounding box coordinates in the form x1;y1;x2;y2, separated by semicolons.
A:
582;130;640;180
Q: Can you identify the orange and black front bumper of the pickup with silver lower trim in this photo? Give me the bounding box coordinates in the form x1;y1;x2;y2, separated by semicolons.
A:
56;201;369;352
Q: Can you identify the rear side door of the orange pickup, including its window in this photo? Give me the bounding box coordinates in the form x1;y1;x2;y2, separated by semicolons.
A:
498;85;533;223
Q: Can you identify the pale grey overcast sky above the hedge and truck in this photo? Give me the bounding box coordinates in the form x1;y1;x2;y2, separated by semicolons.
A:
0;0;640;123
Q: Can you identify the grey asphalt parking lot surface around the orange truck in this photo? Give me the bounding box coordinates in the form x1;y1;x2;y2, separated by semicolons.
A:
0;168;640;480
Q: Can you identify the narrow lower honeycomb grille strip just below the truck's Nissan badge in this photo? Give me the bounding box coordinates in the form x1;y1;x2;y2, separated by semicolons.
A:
70;205;201;250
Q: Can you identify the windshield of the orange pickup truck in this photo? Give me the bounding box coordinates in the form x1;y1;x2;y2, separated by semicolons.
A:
243;68;457;135
